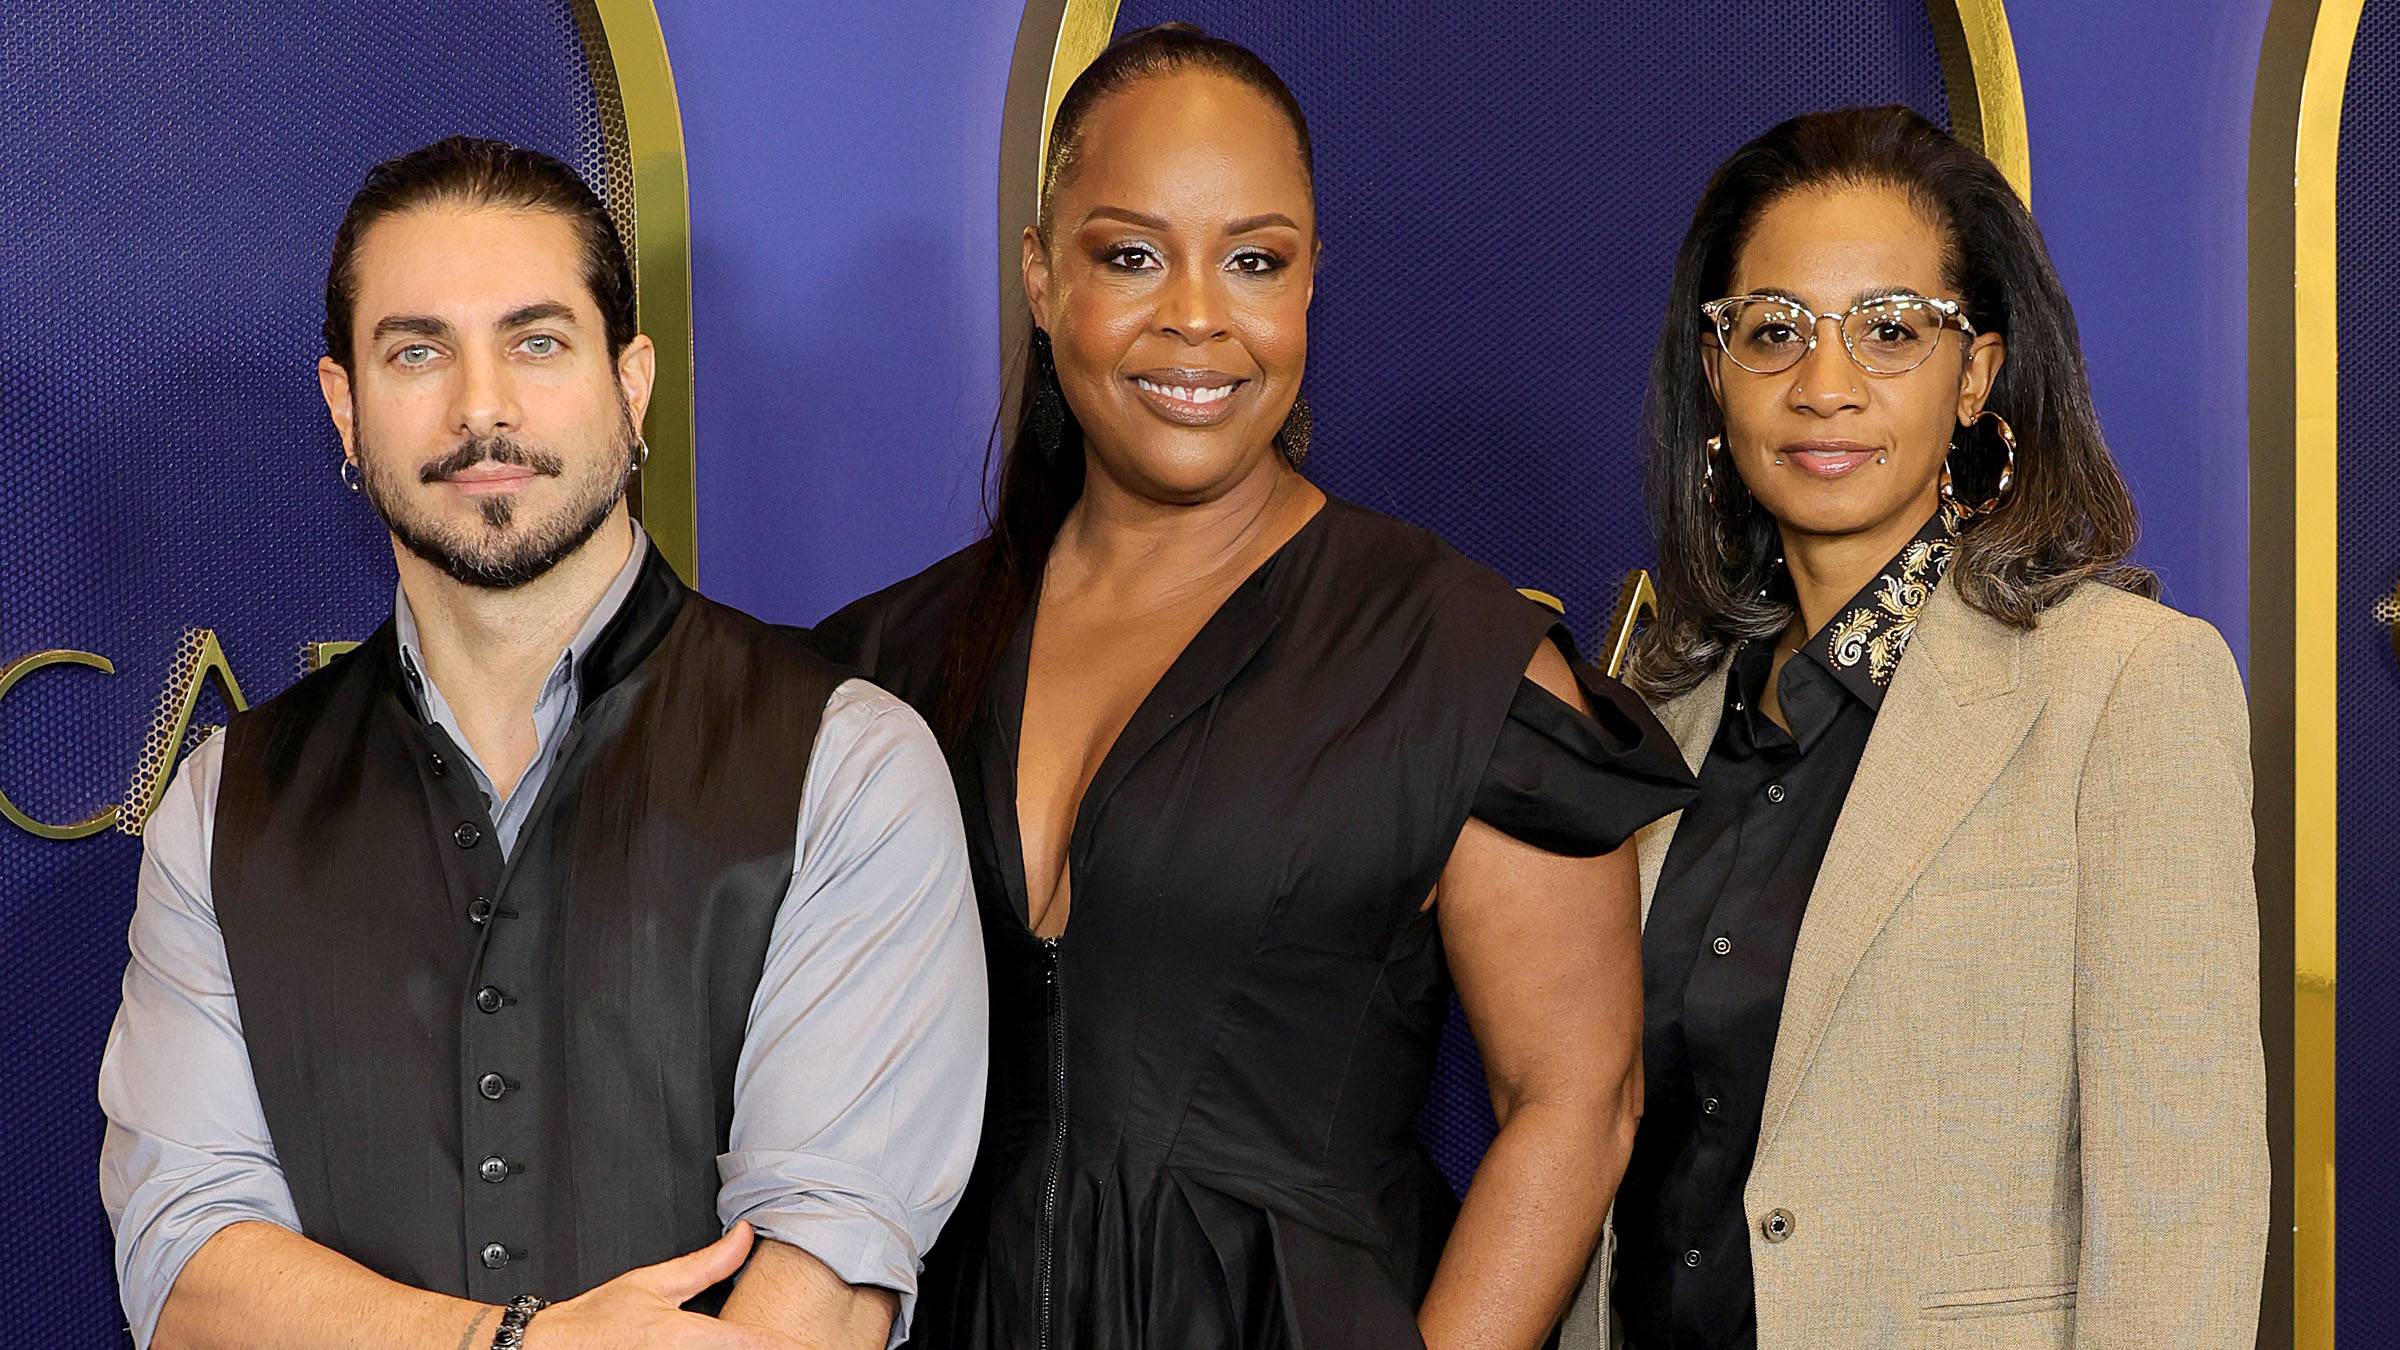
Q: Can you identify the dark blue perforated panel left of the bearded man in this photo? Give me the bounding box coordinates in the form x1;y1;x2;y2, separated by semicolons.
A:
0;0;607;1350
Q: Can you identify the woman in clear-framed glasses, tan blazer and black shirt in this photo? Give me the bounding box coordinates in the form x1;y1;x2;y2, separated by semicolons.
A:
1567;108;2268;1350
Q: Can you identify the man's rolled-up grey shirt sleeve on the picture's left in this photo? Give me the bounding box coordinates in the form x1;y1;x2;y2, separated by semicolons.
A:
101;737;300;1345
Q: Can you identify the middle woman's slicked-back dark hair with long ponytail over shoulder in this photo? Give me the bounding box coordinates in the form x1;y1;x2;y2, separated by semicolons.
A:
934;24;1315;754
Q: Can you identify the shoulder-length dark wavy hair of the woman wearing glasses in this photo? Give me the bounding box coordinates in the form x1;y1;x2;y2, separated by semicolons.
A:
1627;108;2158;697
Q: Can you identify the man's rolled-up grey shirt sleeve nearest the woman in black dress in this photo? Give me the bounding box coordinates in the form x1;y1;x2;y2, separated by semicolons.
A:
718;680;991;1345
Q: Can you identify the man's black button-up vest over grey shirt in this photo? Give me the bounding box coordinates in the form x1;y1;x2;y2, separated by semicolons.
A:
211;550;842;1302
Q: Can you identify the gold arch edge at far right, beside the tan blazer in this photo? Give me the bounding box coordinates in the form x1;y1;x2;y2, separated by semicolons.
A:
2249;0;2364;1350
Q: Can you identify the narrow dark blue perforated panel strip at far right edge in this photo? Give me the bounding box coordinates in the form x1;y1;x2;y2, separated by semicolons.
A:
2335;5;2400;1345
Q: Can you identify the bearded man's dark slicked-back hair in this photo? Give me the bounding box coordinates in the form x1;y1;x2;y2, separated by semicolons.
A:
324;137;636;370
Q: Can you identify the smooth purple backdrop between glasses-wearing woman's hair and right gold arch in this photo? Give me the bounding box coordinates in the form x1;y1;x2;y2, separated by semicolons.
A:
2009;0;2270;665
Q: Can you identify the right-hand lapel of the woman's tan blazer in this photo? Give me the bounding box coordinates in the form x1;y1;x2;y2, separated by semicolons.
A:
1756;589;2045;1158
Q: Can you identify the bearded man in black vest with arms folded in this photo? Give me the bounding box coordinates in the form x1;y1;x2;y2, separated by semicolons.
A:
101;139;986;1350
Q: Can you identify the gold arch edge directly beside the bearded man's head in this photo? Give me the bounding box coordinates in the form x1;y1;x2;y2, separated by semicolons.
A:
576;0;701;581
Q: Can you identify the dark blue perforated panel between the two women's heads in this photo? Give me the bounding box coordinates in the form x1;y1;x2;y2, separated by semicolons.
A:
1116;0;1949;1187
